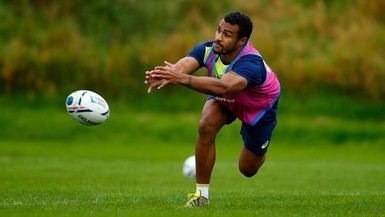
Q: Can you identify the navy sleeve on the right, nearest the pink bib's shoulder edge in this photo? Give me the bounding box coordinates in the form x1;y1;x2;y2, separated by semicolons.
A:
231;55;266;86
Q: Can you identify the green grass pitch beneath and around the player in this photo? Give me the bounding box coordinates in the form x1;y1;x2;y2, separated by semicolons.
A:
0;93;385;217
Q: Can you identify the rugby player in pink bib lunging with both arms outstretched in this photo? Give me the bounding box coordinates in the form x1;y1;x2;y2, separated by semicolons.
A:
145;12;280;207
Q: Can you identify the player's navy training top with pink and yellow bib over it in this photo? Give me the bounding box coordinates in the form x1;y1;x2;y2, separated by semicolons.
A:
188;41;280;125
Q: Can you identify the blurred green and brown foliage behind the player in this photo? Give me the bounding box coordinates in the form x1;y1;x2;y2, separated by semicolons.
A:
0;0;385;100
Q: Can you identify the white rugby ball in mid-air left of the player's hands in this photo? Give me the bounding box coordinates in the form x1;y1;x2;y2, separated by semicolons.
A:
66;90;110;126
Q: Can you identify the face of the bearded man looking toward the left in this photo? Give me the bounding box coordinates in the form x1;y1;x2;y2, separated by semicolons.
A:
214;19;239;54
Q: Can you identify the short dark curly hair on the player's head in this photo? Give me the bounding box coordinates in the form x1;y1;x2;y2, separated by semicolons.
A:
224;11;253;40
